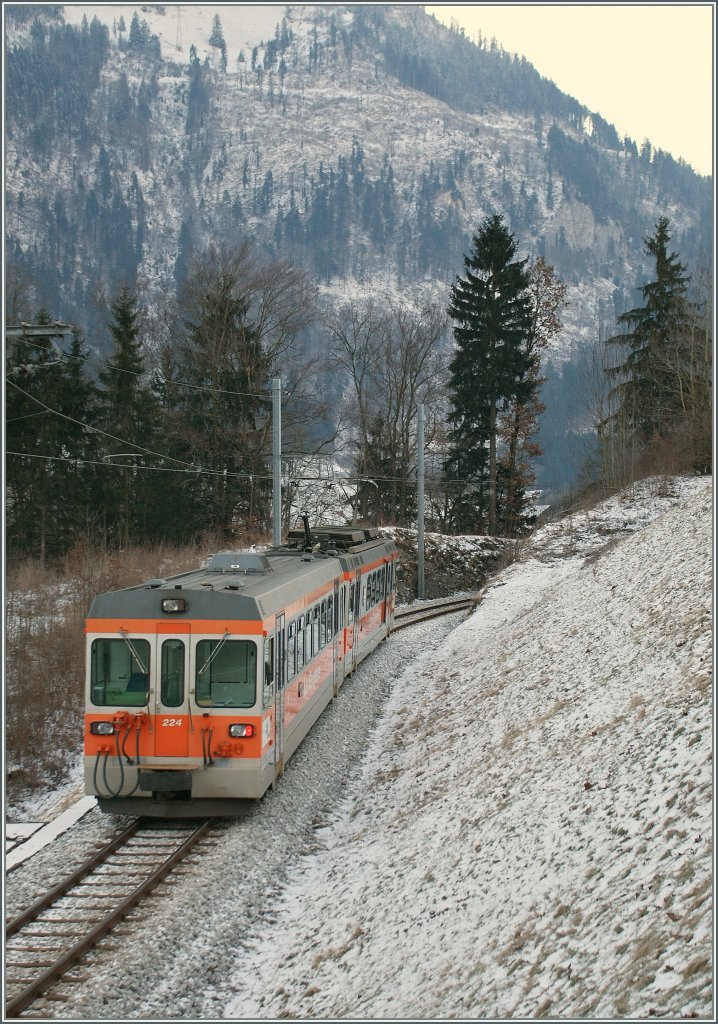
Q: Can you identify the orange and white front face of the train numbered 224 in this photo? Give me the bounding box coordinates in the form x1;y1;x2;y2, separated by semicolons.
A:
85;622;282;814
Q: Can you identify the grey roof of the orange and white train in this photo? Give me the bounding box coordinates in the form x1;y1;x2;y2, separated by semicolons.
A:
88;527;396;621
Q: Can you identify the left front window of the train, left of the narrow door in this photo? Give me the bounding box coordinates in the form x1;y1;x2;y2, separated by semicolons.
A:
90;637;150;708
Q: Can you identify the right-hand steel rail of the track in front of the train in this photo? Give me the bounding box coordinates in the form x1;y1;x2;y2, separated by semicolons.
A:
5;818;212;1018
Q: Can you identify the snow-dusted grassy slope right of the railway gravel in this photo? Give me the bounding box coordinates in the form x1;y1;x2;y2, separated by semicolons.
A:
225;480;715;1019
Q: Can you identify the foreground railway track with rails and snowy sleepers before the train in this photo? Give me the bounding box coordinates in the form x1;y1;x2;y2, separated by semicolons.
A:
5;819;212;1018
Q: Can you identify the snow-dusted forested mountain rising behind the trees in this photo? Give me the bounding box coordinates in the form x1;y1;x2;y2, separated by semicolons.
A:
5;4;712;491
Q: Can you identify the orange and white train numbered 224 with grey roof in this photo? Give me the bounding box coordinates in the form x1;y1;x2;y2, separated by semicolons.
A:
84;515;398;818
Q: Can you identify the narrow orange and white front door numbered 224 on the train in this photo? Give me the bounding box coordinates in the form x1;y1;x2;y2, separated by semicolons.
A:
152;623;192;758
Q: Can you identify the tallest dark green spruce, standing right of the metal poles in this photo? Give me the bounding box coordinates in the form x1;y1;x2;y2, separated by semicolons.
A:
446;214;533;535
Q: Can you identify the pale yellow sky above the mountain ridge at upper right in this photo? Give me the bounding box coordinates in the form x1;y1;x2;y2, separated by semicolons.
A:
426;3;716;174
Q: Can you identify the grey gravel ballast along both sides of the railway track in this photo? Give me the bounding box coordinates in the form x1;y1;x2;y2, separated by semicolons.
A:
5;611;466;1020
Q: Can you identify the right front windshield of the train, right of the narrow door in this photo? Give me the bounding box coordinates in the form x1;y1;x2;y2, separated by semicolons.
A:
195;637;257;708
